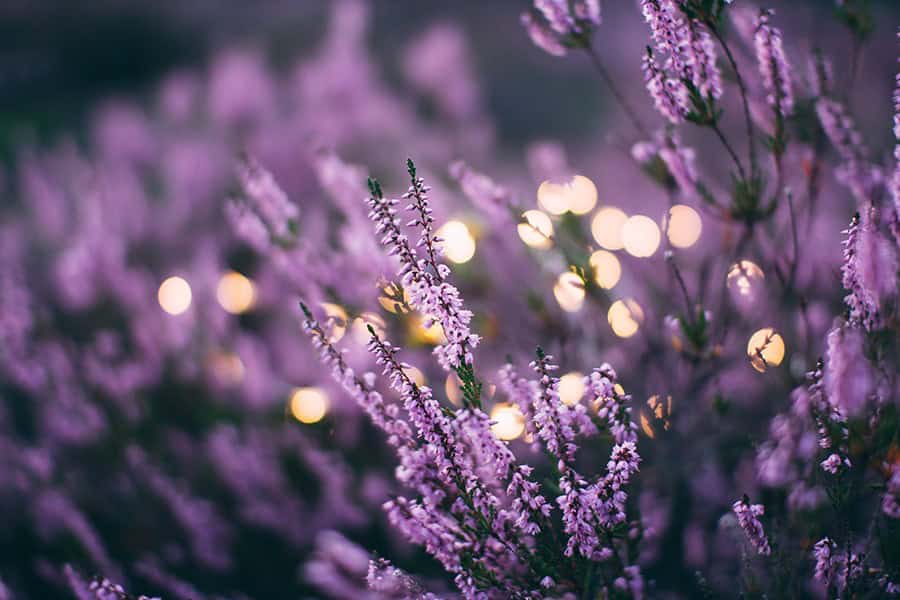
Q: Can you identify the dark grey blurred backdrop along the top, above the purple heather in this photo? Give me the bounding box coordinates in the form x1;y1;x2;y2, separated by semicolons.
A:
0;0;900;158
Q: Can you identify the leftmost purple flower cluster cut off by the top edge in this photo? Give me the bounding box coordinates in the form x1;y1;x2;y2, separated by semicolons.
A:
521;0;602;56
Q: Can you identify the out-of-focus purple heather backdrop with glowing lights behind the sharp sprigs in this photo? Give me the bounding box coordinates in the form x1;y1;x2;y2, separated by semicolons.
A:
0;0;900;600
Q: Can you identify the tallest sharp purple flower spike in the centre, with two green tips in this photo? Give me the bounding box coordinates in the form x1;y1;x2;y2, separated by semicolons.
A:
367;166;480;370
